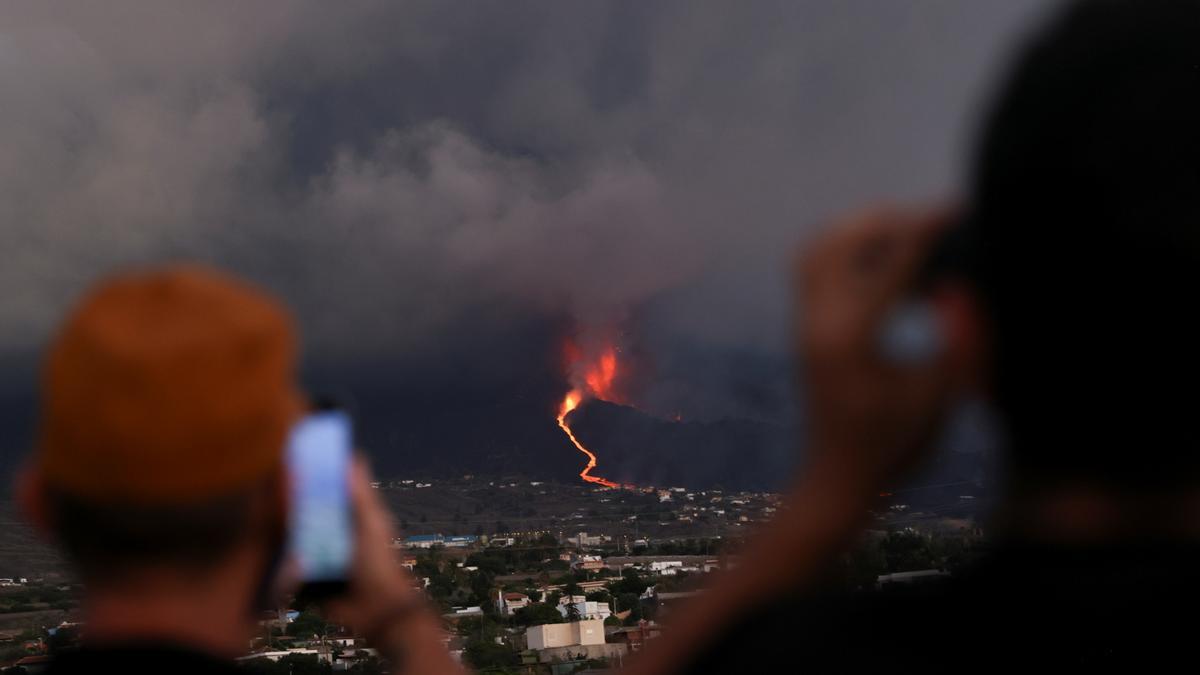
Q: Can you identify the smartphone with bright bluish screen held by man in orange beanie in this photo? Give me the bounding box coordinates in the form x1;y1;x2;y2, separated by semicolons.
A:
287;410;354;599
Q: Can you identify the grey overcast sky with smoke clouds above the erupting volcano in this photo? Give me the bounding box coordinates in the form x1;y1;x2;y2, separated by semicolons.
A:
0;0;1052;470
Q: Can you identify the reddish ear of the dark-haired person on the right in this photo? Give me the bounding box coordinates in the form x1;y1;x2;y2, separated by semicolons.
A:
930;281;991;394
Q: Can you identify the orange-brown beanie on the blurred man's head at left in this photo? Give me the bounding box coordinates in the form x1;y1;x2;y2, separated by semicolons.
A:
36;265;301;504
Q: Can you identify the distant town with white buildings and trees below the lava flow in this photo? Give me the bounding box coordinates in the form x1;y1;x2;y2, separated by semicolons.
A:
0;476;986;675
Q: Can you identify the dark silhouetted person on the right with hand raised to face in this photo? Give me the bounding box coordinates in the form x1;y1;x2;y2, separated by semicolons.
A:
630;0;1200;673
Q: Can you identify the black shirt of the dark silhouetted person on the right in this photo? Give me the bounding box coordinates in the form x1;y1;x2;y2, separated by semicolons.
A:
681;544;1200;673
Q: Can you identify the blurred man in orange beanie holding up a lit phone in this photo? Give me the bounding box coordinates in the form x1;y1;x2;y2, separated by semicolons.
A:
17;265;460;675
